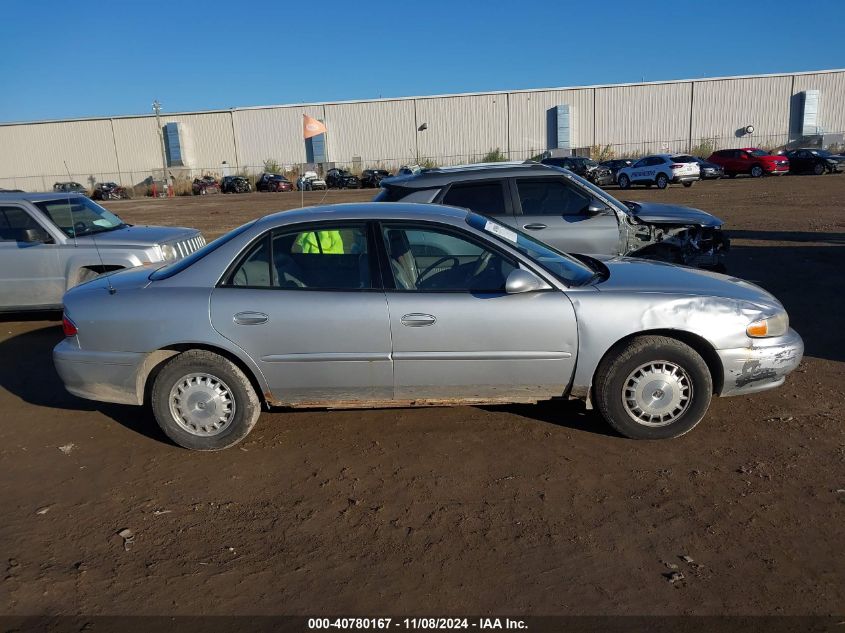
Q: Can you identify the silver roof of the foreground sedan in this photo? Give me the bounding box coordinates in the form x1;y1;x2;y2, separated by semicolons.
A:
258;202;469;225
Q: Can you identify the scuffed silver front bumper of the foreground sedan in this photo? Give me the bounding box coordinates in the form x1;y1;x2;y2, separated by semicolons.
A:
716;328;804;396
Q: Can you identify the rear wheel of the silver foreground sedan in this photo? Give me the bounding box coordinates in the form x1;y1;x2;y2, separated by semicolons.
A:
151;350;261;451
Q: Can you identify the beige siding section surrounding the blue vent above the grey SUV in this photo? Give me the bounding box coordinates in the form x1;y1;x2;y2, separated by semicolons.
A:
509;88;594;158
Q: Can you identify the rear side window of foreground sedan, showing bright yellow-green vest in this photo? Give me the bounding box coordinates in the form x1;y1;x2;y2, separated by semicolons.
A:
226;225;373;290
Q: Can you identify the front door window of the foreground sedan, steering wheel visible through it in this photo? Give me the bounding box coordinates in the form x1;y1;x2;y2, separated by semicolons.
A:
382;224;517;293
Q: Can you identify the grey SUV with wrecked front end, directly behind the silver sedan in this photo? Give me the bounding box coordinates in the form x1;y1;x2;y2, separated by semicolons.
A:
375;162;728;269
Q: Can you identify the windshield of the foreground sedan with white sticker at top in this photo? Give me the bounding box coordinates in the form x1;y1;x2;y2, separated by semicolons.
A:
467;213;598;286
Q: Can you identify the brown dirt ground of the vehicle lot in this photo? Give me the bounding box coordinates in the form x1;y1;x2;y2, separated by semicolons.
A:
0;176;845;615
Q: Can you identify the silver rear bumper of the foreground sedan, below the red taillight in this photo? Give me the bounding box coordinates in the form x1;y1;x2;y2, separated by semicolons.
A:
53;338;146;405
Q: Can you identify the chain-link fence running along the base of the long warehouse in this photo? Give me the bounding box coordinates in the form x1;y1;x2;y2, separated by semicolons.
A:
0;132;845;196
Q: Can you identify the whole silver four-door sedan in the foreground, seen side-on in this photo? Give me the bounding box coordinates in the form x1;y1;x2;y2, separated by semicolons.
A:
54;203;803;450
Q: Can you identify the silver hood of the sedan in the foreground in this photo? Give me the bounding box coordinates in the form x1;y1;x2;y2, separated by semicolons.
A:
595;257;781;307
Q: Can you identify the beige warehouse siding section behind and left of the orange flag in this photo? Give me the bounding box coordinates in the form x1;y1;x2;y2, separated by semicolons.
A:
234;106;316;165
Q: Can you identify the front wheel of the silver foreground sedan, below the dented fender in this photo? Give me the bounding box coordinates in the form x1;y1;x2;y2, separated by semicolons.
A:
594;336;713;440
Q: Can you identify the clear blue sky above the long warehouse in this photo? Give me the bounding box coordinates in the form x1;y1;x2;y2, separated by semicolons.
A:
0;0;845;121
